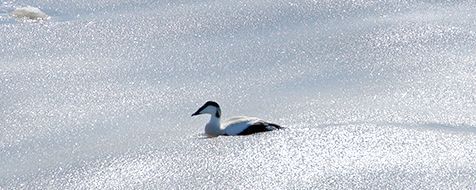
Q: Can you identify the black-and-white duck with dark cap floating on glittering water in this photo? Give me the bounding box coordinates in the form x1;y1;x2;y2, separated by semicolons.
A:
192;101;283;137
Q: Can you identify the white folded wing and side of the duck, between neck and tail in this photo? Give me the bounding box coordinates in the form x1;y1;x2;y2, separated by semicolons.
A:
222;116;261;135
